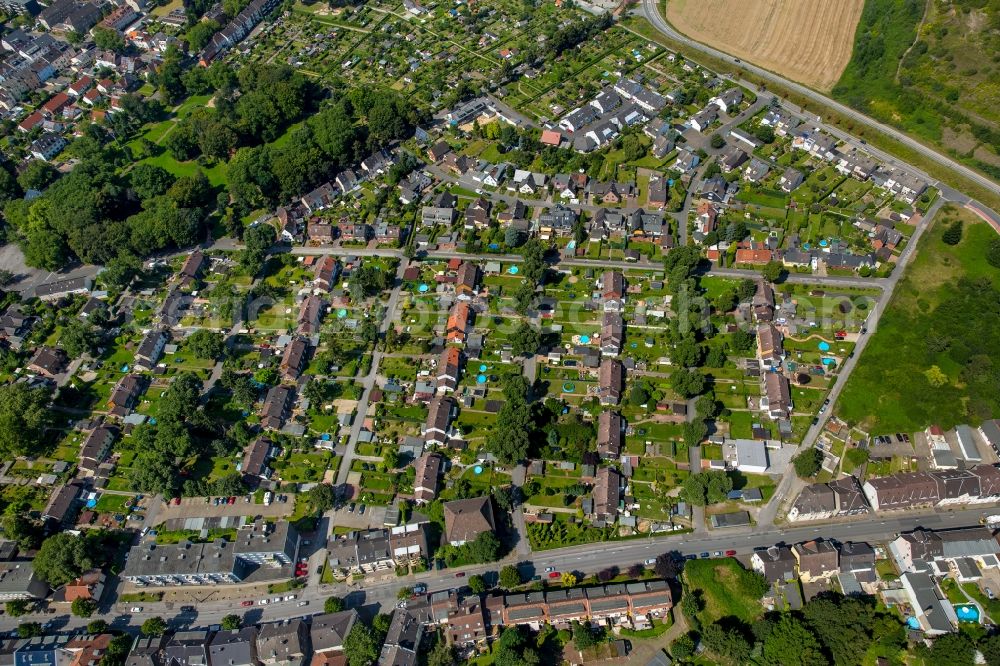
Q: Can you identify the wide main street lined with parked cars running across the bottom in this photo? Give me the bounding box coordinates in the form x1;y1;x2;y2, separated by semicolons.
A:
15;507;992;631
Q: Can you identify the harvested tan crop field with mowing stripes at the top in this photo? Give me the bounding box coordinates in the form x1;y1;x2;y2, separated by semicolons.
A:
667;0;865;90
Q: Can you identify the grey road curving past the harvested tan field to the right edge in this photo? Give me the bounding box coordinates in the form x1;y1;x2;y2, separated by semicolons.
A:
641;0;1000;202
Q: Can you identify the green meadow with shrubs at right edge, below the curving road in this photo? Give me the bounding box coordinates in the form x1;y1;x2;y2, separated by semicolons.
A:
836;206;1000;433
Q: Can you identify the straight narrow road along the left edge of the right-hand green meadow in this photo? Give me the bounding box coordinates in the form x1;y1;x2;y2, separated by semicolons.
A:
757;198;944;525
